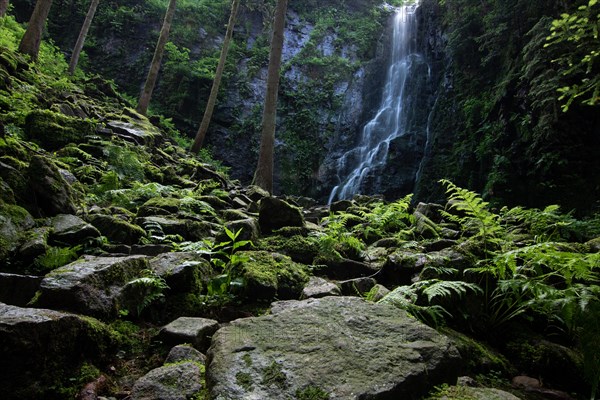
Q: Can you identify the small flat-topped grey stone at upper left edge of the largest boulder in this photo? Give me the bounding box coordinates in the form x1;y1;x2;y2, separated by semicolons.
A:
159;317;219;351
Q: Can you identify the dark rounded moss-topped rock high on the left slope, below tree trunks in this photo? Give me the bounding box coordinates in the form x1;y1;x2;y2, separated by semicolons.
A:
25;110;96;150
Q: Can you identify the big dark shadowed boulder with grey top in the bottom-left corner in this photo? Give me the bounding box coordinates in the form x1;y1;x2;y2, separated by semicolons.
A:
0;303;115;400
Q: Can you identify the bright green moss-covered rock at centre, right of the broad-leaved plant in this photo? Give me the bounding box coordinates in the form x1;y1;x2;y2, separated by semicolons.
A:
239;251;309;300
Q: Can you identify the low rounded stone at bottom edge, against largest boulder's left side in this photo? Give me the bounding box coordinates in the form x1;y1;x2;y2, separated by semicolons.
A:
129;361;203;400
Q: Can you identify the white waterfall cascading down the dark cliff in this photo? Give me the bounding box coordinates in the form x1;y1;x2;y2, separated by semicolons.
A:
328;2;423;203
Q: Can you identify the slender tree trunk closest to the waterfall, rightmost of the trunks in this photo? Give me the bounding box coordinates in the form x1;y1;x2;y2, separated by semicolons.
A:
254;0;288;193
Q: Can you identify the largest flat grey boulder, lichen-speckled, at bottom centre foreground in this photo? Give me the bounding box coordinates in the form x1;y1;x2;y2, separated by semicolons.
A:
207;297;461;400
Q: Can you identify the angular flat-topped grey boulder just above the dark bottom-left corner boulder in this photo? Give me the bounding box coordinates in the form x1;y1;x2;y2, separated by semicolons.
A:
36;256;148;318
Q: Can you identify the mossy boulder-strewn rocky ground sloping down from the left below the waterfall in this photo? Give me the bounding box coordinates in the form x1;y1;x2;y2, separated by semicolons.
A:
0;34;599;399
